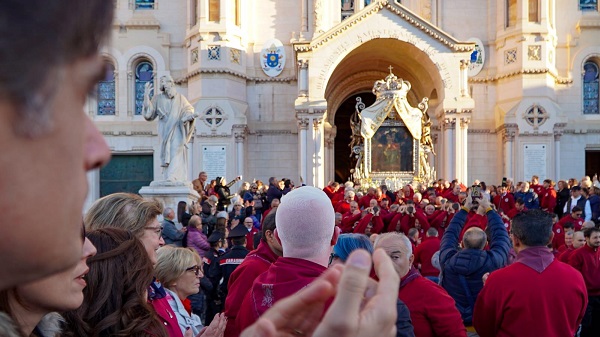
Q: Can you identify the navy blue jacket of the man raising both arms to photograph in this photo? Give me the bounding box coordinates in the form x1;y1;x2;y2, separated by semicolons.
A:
440;209;511;325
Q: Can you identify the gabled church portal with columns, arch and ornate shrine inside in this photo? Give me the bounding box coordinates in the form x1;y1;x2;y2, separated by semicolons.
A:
292;2;474;187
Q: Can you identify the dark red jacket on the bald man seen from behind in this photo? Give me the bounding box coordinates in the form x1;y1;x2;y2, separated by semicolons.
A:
236;257;330;331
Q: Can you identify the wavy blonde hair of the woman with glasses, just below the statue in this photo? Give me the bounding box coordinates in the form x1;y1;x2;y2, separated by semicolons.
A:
84;193;163;238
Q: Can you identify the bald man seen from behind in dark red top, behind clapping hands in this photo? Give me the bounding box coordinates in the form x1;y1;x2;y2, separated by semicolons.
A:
236;186;339;331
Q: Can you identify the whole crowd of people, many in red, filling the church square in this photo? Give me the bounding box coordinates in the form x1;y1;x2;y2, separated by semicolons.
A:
0;0;600;337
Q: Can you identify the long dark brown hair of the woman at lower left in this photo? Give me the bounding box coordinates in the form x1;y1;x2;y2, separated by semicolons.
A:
64;228;167;337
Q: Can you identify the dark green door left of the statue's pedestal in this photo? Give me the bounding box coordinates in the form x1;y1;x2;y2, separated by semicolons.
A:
100;154;154;197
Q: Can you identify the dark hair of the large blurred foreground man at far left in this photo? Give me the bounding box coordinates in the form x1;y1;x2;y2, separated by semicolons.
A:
0;0;114;136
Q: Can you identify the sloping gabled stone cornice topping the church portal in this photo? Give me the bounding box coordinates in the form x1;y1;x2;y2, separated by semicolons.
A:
292;0;475;52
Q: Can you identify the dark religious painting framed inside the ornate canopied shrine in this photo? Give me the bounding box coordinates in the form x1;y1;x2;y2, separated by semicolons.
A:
371;125;414;173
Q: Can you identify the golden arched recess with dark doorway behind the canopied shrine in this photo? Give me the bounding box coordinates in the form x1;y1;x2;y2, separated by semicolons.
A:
325;39;443;182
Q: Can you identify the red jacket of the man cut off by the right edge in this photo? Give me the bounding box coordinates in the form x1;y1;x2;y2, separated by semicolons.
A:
569;243;600;296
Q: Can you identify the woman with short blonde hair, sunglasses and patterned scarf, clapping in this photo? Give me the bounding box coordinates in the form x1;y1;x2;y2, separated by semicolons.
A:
154;246;227;337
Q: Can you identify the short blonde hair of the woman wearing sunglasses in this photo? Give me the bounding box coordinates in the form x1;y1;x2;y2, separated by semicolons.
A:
154;246;202;288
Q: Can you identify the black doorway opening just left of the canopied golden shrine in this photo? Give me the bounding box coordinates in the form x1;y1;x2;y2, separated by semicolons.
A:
334;92;375;182
